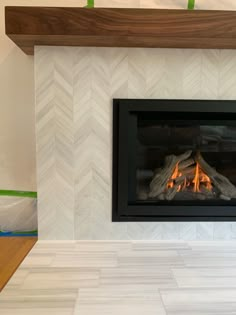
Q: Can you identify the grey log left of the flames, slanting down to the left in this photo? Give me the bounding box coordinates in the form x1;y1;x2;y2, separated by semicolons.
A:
149;151;192;198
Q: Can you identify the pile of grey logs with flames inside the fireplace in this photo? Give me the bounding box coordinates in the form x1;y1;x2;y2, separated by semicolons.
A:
147;151;236;200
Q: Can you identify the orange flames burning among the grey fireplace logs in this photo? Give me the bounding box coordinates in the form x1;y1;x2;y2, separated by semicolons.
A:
166;163;212;192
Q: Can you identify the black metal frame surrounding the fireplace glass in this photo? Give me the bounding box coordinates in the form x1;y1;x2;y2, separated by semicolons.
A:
112;99;236;222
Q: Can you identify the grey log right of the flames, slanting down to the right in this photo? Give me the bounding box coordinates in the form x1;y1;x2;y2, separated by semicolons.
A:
195;153;236;198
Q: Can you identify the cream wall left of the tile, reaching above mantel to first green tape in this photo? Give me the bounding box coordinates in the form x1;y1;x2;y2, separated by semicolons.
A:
0;0;86;190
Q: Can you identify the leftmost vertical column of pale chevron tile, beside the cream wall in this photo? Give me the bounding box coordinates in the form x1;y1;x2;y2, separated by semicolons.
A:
35;48;75;239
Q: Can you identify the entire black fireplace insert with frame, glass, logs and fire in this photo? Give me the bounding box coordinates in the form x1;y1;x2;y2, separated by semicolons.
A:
112;99;236;221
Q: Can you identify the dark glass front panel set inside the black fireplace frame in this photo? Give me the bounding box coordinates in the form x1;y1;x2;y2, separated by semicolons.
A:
129;112;236;205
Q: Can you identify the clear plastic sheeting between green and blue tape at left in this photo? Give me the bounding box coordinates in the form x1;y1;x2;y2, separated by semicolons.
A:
0;196;38;232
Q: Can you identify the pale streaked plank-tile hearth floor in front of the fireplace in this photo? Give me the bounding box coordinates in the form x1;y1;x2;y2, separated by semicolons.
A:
0;241;236;315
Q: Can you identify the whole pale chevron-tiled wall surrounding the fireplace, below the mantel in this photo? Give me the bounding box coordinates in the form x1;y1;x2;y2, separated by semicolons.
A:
35;47;236;240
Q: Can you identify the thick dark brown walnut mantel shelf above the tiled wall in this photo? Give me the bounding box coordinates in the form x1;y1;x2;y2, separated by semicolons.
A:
5;7;236;54
